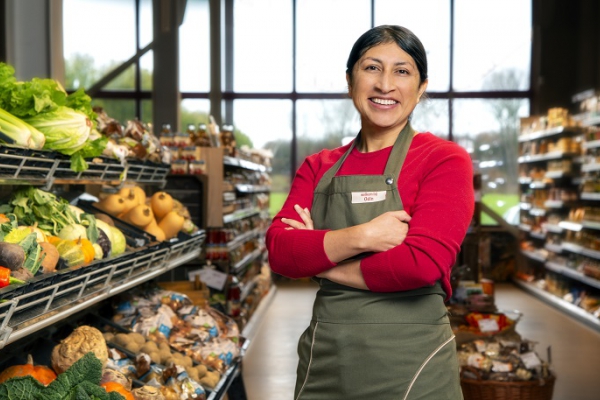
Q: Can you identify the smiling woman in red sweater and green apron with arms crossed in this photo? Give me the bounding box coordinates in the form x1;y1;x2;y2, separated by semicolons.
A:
266;26;474;400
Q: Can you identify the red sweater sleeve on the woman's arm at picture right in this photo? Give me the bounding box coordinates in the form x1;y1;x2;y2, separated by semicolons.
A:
361;141;474;296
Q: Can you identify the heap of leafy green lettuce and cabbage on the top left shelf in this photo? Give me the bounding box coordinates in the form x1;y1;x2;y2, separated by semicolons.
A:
0;62;108;172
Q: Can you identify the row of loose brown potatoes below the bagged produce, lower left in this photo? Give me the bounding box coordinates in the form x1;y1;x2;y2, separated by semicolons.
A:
103;332;221;388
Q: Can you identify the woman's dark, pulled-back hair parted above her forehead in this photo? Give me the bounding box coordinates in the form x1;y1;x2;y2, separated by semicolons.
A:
346;25;427;83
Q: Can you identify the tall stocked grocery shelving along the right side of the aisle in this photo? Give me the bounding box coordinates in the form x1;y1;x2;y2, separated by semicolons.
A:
515;115;600;331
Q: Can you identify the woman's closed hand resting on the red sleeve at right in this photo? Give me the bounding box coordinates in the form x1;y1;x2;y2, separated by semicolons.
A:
363;210;411;252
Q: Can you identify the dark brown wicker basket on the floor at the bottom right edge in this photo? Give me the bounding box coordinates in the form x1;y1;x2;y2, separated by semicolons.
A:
460;367;556;400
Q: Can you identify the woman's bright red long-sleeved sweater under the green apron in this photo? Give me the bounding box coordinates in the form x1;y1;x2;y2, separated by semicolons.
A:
266;133;474;296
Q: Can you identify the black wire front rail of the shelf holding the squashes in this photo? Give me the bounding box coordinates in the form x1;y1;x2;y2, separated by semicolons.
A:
0;242;201;348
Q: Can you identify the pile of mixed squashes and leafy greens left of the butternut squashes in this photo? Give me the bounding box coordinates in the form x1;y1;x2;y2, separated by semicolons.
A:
0;186;126;288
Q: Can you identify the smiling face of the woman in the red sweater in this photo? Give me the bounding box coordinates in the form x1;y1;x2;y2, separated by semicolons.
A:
346;43;427;134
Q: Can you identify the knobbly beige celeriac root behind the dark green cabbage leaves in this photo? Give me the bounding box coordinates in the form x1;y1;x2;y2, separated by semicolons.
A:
52;325;108;374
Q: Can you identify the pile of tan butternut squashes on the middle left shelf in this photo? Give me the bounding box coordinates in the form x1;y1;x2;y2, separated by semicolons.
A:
94;186;185;242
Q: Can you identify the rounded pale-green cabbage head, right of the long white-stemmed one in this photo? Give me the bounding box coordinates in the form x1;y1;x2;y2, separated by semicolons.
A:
24;106;92;155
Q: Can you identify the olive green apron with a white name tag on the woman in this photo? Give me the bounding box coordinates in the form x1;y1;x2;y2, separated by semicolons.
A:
294;124;463;400
